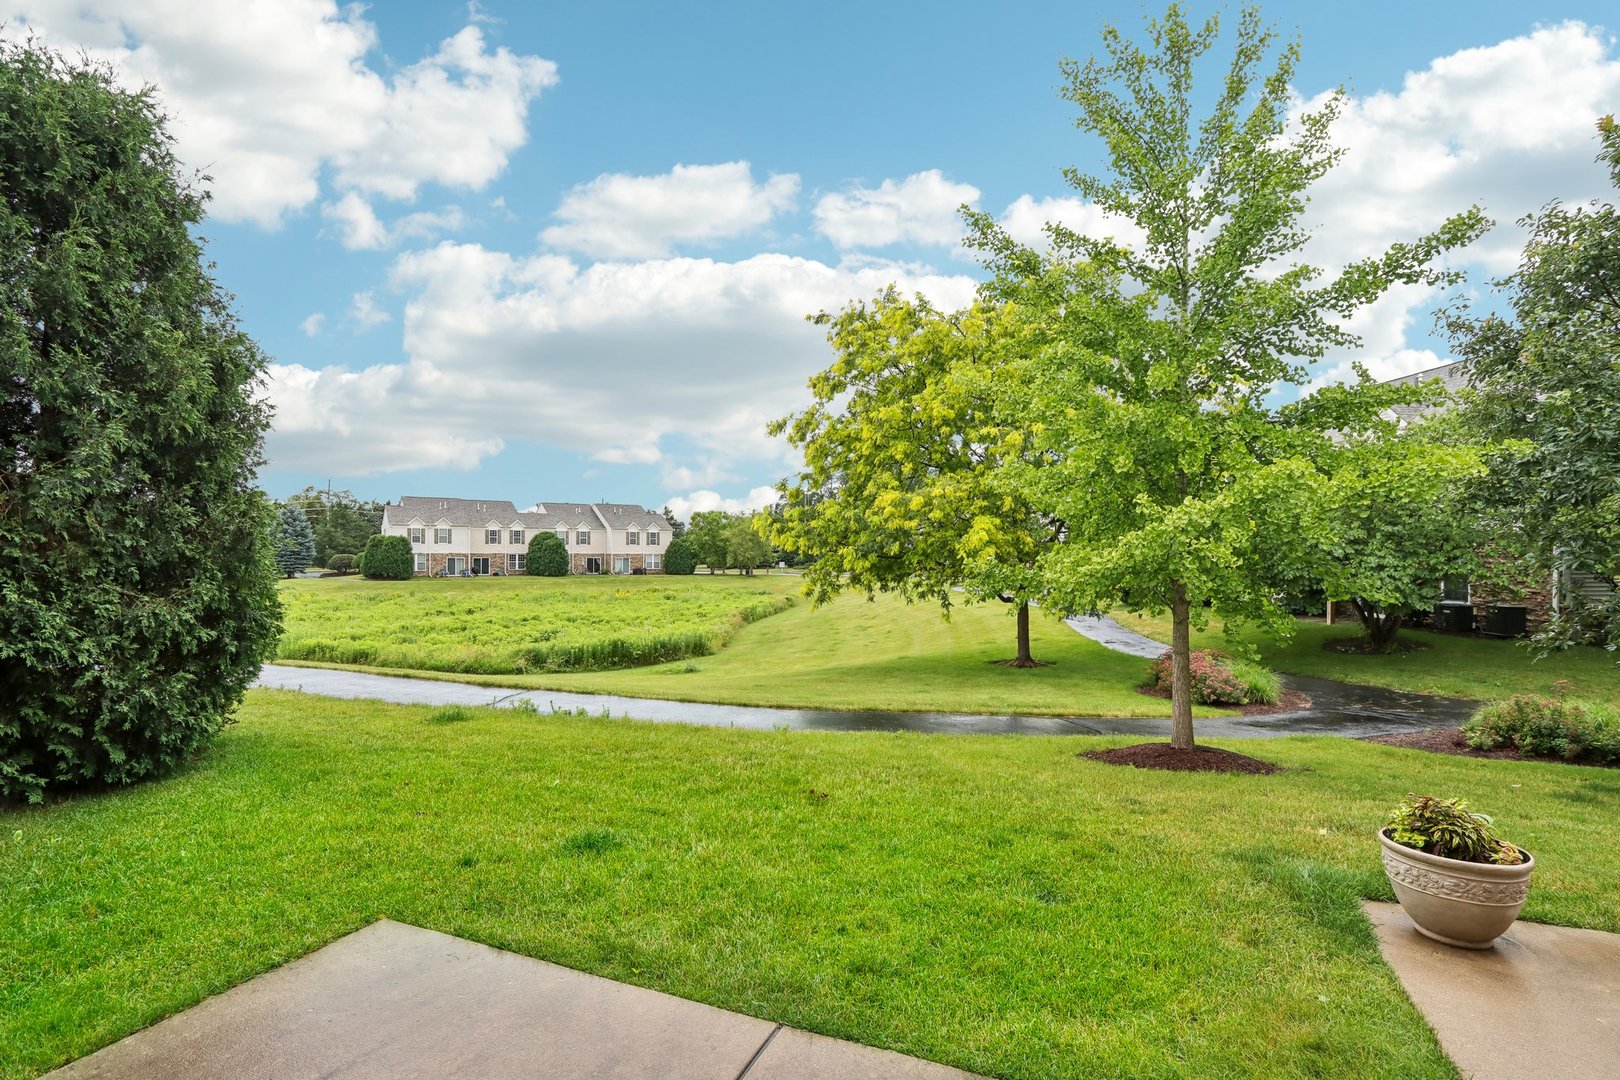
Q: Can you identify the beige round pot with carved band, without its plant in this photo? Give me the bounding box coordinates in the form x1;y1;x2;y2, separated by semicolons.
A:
1379;829;1536;949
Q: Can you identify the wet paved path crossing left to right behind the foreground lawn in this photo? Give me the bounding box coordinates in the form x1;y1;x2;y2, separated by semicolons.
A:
254;664;1451;738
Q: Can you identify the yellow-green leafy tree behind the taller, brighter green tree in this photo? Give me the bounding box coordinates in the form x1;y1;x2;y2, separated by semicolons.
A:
768;288;1063;667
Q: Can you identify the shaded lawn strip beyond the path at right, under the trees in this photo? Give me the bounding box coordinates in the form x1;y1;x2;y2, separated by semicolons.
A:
1113;612;1620;701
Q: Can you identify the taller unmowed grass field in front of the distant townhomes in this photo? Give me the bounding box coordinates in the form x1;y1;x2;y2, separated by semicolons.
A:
279;576;794;674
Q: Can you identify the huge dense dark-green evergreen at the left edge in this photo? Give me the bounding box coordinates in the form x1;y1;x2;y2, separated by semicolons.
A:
0;40;279;798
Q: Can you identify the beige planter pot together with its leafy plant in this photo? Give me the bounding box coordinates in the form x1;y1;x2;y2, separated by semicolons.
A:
1379;795;1536;949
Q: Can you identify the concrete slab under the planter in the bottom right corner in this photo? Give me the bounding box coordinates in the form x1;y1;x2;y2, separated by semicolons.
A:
1364;904;1620;1080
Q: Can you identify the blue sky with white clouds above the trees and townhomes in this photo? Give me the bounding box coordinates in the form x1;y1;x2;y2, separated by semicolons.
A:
0;0;1620;513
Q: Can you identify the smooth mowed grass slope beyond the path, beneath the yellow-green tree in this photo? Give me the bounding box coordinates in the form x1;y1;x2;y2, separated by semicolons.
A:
285;575;1221;716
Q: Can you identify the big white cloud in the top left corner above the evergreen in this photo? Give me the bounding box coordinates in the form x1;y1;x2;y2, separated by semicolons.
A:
0;0;557;228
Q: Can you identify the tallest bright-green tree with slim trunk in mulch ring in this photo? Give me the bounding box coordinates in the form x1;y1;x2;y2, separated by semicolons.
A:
970;6;1484;748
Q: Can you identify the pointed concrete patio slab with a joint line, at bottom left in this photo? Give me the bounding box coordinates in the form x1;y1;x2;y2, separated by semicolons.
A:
49;920;977;1080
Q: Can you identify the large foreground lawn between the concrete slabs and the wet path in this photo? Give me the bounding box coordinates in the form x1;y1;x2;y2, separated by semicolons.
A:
0;691;1620;1080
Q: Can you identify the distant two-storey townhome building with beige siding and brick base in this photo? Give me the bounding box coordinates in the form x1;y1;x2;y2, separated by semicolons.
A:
382;495;671;576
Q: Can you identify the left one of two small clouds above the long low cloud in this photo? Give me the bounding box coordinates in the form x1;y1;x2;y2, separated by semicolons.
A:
541;162;799;259
